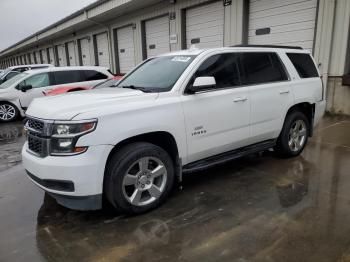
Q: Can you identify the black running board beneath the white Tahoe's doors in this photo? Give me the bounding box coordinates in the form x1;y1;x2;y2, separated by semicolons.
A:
182;139;276;173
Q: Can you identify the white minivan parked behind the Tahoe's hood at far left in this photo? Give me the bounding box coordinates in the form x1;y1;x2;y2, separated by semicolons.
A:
0;66;113;122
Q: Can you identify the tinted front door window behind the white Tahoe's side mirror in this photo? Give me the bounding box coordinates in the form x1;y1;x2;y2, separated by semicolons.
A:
191;54;240;88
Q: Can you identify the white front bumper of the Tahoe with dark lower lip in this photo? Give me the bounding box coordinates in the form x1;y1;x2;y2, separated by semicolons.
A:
22;143;113;210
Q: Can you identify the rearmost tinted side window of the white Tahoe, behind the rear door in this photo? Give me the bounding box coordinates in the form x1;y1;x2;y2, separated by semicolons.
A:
287;53;318;78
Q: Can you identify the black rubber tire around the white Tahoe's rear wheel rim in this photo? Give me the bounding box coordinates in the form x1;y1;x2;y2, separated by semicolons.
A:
275;111;310;157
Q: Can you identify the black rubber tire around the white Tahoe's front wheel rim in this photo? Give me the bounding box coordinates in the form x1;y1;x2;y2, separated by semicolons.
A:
104;142;174;214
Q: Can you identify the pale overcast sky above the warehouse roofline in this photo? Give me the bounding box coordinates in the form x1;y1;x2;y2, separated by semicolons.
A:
0;0;96;51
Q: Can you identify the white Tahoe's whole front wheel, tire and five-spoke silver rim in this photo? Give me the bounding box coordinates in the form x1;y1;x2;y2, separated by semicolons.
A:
104;143;174;214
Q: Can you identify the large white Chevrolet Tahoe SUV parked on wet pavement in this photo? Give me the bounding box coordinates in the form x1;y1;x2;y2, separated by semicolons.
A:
22;46;325;213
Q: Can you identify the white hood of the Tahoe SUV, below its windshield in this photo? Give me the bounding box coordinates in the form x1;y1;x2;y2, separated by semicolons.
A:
26;88;158;120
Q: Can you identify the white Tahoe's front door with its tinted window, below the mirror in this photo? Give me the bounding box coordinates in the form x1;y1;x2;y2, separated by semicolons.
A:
182;53;250;163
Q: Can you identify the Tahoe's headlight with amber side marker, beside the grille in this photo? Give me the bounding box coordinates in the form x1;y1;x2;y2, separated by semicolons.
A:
50;120;97;156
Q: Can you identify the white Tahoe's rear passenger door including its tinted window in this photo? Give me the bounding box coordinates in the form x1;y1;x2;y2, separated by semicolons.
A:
240;52;294;143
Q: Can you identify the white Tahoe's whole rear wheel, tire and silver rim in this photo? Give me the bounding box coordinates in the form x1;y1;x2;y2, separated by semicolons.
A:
276;111;310;157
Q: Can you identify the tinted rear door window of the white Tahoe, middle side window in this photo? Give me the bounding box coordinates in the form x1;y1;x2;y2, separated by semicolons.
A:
240;53;288;85
